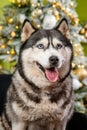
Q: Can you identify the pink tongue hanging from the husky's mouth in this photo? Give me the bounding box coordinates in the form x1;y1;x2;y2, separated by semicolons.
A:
45;69;59;82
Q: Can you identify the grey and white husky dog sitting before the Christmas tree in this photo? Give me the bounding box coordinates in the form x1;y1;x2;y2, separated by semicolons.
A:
0;18;73;130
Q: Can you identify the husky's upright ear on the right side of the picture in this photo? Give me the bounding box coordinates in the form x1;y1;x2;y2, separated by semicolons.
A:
56;18;70;39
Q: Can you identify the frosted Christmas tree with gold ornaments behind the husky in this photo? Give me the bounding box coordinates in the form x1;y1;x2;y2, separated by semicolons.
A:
0;0;87;112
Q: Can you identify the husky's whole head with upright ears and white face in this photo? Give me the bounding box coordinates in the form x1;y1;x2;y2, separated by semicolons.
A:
19;19;73;87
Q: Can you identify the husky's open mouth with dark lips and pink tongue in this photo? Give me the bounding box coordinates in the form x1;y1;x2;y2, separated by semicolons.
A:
36;62;59;83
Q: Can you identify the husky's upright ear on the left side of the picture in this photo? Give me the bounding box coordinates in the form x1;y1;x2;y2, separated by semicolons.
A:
21;19;35;42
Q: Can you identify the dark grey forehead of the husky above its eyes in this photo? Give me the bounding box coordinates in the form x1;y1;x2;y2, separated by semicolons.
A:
22;29;70;49
